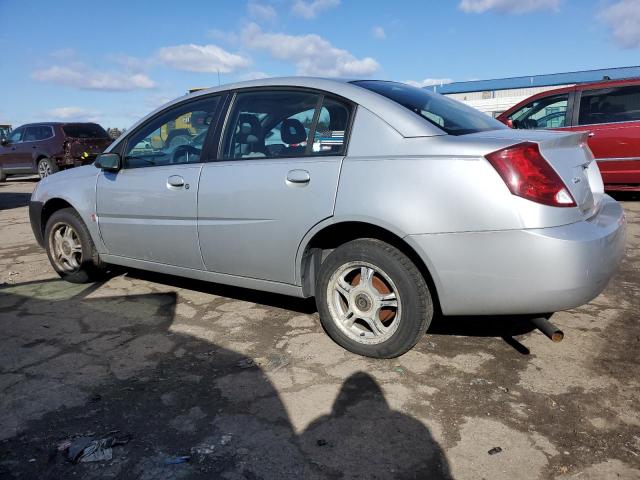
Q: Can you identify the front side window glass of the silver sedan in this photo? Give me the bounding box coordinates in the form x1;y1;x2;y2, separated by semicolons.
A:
123;97;220;168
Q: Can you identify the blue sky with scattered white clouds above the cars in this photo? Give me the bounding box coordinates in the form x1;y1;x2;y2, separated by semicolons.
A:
0;0;640;127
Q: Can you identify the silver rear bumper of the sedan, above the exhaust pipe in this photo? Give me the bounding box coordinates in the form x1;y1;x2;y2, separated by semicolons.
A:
407;196;626;315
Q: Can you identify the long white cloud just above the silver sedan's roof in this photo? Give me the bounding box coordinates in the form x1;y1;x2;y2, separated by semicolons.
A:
242;23;380;77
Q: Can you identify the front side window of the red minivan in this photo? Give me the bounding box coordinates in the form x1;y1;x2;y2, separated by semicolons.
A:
509;94;569;129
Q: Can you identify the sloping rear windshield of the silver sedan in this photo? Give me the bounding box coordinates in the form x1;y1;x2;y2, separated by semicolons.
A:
352;80;507;135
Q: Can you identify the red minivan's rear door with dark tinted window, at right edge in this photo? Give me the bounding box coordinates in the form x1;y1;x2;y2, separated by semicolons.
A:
571;85;640;185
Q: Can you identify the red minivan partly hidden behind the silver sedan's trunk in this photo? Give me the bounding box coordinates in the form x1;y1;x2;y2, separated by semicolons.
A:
497;78;640;191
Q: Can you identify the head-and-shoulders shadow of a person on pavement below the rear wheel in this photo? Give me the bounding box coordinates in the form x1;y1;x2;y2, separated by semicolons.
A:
300;372;452;480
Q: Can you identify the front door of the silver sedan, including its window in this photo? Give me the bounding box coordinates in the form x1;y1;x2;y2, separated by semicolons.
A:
96;95;220;270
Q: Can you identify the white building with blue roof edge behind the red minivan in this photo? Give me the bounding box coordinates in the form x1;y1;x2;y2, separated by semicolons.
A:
425;66;640;117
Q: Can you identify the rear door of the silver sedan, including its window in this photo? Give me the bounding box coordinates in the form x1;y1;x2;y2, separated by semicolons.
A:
198;89;353;284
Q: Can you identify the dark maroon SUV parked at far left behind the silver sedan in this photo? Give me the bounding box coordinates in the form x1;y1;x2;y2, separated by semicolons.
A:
0;123;112;182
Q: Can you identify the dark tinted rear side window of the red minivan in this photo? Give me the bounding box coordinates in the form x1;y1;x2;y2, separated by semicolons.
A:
578;85;640;125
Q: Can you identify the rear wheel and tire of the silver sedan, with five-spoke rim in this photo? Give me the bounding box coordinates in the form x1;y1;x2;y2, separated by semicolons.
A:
316;238;433;358
